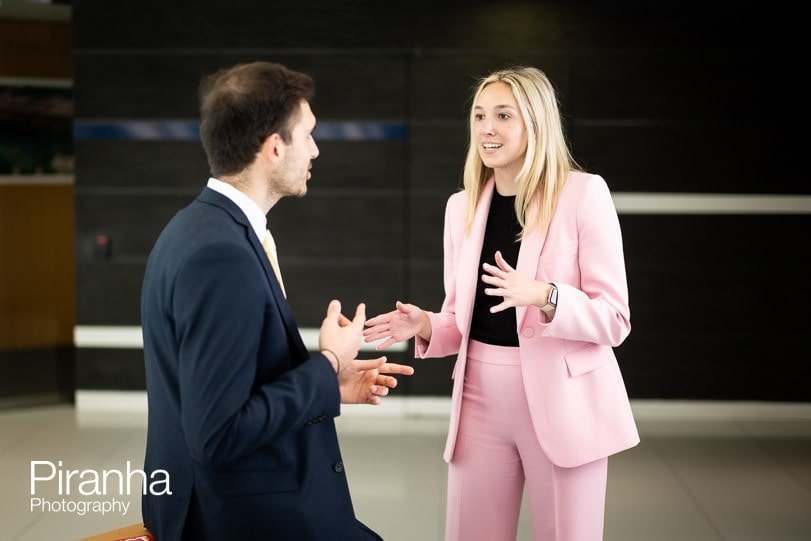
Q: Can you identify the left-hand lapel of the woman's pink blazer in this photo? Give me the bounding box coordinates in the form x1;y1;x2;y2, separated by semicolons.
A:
456;178;495;334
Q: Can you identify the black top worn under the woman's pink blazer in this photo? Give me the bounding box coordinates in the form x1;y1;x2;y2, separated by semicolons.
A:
470;190;521;346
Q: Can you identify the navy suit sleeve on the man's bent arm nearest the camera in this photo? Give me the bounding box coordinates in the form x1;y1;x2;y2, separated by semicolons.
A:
171;242;340;465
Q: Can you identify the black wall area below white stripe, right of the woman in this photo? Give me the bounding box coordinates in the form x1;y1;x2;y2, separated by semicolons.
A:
617;215;811;400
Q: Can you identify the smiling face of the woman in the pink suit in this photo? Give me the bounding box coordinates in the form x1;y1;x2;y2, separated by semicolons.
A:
472;83;527;175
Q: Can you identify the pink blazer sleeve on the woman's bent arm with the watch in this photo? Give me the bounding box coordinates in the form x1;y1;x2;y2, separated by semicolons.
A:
544;175;631;347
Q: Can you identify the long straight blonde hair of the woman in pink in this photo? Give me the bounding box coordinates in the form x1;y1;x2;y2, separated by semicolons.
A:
464;66;578;234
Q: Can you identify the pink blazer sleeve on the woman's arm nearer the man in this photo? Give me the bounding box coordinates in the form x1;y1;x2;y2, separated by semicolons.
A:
414;194;462;359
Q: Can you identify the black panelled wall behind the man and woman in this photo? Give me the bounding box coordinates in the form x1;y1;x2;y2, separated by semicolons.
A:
73;0;811;400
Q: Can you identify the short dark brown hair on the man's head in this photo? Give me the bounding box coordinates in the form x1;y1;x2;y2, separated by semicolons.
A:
200;62;315;177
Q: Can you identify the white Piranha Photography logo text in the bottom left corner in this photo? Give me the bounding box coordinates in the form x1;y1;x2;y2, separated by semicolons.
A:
29;460;172;516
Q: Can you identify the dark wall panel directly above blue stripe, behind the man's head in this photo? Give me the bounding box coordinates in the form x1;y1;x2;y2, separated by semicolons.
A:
75;50;409;119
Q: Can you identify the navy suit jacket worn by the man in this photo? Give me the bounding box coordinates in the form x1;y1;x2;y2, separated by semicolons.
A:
141;188;380;541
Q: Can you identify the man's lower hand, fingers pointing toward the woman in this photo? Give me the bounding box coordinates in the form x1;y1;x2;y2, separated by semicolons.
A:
338;357;414;405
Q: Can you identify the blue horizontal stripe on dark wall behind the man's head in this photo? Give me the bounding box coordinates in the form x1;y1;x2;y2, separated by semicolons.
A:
73;120;408;141
